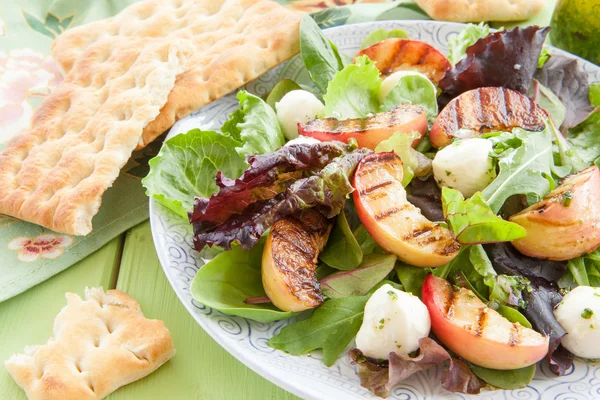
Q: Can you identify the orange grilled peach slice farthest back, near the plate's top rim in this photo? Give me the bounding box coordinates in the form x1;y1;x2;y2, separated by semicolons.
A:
356;38;452;84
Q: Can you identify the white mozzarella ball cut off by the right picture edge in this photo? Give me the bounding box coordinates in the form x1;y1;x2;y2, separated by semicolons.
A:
554;286;600;359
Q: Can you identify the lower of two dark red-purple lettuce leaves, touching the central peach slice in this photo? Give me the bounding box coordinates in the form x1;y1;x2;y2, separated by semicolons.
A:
194;149;371;251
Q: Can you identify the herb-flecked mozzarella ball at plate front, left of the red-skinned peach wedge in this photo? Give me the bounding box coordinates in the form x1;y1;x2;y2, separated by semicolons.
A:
356;284;431;360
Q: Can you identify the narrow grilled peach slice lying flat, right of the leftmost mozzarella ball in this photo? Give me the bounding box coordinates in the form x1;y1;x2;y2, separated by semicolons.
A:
298;104;427;150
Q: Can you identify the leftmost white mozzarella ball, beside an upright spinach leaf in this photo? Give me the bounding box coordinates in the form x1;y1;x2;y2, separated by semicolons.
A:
275;90;325;140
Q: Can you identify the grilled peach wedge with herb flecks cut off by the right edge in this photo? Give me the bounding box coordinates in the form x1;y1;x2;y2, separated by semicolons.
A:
509;166;600;261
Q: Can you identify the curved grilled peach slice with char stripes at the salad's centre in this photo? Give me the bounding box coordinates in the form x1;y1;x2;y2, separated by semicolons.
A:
353;153;460;267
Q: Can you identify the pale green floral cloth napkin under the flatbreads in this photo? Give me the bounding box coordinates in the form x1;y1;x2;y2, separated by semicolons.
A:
0;0;427;301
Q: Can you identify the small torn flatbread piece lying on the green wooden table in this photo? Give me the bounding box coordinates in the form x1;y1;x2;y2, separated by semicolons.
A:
5;288;175;400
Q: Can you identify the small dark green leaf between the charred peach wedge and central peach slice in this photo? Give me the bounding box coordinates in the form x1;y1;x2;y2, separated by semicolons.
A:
319;210;363;270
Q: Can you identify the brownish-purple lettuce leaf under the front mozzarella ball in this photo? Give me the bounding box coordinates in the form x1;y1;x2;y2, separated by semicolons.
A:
348;338;483;398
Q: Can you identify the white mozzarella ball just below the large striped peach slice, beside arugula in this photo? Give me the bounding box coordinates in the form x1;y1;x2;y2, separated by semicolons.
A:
432;138;496;197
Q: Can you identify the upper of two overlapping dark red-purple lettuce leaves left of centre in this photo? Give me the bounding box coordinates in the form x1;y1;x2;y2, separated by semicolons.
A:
189;142;353;232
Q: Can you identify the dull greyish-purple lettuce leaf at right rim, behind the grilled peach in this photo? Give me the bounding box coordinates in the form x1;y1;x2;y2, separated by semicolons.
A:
535;55;594;131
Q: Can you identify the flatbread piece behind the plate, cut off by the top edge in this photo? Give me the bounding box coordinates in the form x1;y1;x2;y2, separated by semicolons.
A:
417;0;544;22
